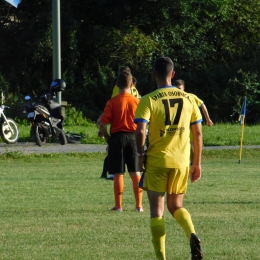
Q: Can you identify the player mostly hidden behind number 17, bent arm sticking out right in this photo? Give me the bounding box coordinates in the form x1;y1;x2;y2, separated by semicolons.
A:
174;79;213;163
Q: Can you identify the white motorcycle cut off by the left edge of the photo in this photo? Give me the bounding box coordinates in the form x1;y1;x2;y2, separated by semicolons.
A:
0;105;19;144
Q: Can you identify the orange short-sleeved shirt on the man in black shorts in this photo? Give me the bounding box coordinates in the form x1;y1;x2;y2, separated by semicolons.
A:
100;93;139;134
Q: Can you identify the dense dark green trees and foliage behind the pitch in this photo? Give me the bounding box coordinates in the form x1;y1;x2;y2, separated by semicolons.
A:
0;0;260;123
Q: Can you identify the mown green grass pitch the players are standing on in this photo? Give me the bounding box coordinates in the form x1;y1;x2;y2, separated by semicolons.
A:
0;149;260;260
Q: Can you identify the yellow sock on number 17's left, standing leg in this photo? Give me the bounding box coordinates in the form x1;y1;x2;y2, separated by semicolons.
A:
150;217;166;260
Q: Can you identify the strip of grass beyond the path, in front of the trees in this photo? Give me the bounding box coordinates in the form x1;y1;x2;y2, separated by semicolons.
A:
11;123;260;146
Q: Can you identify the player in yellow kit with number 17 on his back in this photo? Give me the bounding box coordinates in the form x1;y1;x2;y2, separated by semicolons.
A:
134;57;203;260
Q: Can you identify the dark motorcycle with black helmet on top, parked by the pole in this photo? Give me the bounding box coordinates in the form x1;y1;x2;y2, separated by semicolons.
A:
25;79;67;146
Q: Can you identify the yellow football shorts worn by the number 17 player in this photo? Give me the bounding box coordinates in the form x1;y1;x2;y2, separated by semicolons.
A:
139;161;189;194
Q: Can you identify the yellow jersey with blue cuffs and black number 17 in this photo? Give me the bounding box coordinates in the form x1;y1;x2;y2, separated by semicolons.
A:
134;86;202;168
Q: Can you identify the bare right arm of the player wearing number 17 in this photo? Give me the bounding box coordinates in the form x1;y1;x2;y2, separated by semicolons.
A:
190;123;203;182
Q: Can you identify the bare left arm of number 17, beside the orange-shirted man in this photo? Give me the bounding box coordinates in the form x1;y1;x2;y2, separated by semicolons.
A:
135;122;146;172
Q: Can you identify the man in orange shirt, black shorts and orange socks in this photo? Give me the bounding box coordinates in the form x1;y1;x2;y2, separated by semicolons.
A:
99;71;143;212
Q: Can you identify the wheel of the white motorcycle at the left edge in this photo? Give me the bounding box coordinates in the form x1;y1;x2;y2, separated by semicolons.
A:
0;118;19;144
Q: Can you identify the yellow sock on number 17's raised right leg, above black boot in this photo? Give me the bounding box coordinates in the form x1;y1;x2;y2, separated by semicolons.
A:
173;208;195;240
